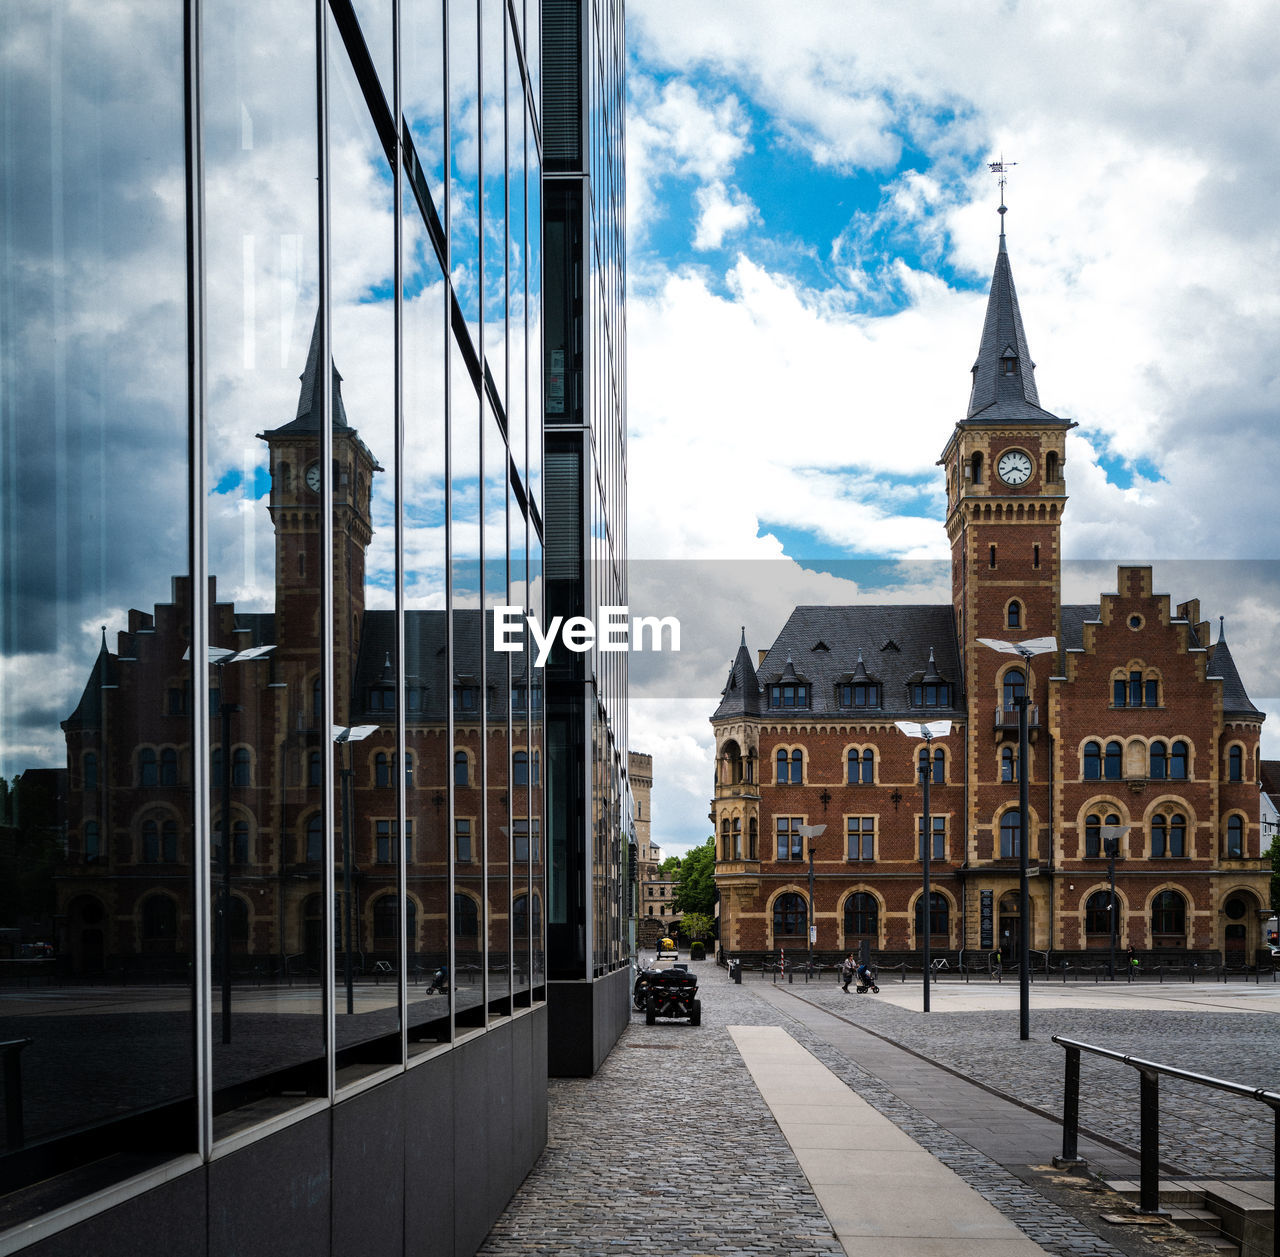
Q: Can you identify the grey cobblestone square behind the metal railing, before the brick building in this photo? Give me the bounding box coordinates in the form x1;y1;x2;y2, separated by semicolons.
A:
788;982;1280;1179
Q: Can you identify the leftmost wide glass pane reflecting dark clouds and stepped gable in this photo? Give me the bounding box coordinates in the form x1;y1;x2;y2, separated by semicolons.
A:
0;3;194;1203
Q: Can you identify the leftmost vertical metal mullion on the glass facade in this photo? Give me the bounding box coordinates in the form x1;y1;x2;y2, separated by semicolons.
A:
183;0;214;1161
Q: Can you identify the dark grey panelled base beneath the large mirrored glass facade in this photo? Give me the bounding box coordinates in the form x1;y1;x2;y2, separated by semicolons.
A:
0;1005;548;1257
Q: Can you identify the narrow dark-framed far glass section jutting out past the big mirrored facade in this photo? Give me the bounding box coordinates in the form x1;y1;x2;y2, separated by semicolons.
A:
543;0;635;1074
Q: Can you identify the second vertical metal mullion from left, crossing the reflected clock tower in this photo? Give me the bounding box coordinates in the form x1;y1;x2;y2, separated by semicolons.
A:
315;0;337;1102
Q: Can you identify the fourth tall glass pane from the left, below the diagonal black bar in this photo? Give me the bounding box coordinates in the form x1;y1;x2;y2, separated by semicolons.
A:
403;157;458;1053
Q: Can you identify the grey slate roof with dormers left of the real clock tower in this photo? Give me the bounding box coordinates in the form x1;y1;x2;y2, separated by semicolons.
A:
732;603;965;719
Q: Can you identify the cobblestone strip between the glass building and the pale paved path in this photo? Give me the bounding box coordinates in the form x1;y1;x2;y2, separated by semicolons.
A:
480;963;844;1257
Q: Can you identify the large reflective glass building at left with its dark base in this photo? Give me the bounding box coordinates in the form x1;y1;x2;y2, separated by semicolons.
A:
0;0;581;1253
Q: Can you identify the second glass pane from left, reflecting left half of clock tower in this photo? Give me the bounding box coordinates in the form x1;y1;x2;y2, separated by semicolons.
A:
204;0;329;1135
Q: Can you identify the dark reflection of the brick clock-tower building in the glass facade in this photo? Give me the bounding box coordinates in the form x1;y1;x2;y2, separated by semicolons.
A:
58;320;543;1039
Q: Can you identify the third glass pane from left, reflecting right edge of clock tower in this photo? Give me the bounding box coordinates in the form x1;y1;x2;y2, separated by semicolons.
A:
329;18;404;1084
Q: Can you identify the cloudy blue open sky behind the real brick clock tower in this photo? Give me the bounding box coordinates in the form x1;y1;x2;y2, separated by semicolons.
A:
627;0;1280;854
